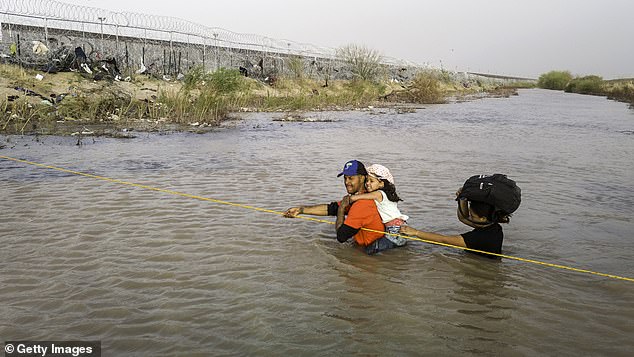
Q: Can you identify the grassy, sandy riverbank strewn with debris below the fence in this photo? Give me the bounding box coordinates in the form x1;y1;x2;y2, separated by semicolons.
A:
0;64;515;137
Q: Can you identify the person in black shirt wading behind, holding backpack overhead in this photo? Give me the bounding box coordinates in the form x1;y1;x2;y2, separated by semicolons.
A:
401;191;509;258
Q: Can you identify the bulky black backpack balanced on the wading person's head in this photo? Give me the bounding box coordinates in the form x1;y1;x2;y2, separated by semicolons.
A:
458;174;522;216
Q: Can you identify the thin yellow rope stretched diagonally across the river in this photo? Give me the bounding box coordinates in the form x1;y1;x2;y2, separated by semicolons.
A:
0;155;634;282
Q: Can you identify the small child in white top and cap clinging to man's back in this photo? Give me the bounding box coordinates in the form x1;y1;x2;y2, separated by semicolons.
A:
350;164;409;247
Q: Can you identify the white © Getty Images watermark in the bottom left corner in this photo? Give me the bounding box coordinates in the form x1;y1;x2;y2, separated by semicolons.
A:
4;341;101;357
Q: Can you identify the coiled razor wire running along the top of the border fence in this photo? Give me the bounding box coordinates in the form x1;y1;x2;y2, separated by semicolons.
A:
0;0;417;67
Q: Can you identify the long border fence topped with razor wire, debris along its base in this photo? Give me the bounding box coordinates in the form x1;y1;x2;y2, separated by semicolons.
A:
0;0;419;78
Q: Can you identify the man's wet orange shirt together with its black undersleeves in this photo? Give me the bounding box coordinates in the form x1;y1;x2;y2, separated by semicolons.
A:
328;200;382;250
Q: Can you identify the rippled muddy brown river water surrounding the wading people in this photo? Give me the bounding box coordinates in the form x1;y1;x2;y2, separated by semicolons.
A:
0;90;634;356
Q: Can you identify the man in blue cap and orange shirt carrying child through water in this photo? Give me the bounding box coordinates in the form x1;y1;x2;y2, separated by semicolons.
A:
284;160;396;255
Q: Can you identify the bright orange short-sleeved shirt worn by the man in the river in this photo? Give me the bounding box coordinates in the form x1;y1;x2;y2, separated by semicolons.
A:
343;200;385;247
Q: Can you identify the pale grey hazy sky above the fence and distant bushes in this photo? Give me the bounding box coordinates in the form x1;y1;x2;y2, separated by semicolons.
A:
80;0;634;79
